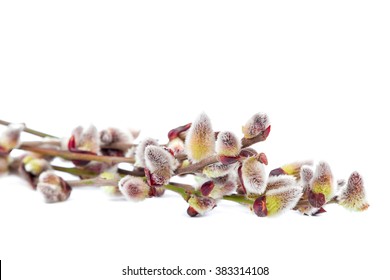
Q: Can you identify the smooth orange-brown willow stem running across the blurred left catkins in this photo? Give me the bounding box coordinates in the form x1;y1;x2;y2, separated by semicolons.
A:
18;145;135;164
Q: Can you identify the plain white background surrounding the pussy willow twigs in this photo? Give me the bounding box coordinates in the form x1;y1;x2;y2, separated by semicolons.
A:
0;0;390;280
